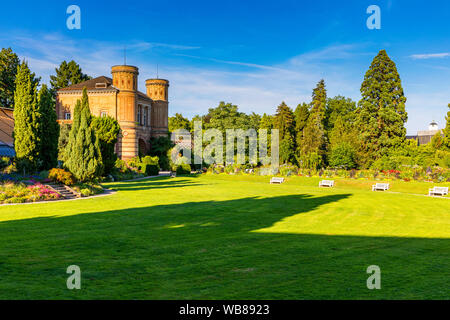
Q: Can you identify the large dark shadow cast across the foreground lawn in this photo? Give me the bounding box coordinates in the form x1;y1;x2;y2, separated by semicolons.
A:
0;192;450;299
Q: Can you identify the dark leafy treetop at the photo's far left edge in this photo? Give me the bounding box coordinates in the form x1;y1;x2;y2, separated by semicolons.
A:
0;48;20;108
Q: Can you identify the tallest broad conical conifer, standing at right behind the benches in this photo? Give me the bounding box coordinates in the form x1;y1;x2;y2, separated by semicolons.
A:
357;50;408;167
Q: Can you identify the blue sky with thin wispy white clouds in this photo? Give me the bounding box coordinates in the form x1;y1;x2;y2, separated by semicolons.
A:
0;0;450;134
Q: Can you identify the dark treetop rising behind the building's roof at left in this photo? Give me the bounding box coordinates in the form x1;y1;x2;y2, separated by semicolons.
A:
50;60;91;95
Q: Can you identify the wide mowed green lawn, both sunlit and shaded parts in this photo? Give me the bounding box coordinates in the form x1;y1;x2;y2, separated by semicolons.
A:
0;175;450;299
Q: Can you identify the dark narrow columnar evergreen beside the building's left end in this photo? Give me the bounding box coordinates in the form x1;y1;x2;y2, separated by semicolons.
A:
38;84;59;170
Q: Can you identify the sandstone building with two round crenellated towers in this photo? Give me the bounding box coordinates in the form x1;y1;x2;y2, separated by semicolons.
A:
56;65;169;160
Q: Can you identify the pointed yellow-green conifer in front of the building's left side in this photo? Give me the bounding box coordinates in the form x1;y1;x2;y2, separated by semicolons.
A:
64;88;103;182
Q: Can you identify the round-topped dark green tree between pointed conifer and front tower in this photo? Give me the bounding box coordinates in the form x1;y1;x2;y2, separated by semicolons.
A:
91;116;120;175
